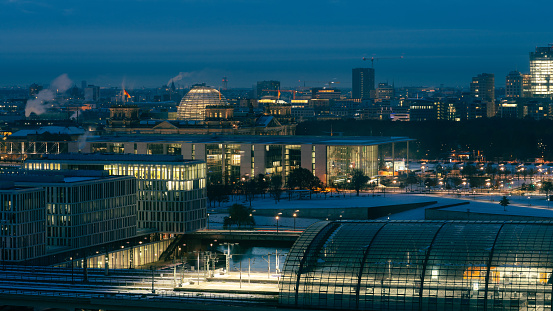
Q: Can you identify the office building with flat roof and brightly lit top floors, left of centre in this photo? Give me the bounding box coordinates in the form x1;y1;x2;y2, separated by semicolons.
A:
24;154;206;233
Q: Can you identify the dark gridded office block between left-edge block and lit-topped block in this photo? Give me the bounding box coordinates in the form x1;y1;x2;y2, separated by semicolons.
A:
0;170;137;249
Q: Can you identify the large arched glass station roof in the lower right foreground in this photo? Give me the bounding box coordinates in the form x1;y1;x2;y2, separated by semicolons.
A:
279;221;553;310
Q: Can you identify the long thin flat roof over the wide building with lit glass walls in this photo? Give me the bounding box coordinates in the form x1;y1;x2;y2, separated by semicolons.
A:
87;135;415;146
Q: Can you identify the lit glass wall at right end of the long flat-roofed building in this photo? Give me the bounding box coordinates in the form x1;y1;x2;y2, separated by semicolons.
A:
326;145;378;184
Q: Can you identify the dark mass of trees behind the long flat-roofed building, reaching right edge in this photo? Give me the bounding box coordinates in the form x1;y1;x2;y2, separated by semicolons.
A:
296;118;553;161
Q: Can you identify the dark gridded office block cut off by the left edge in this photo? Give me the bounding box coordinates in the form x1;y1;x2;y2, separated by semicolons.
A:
0;182;46;264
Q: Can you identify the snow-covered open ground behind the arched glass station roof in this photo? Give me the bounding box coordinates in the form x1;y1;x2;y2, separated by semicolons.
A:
208;192;553;230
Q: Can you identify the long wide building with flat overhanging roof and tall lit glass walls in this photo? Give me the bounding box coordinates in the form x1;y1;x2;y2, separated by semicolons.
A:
77;135;412;185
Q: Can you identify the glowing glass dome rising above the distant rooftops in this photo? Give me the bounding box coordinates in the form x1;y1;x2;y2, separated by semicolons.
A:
177;85;228;121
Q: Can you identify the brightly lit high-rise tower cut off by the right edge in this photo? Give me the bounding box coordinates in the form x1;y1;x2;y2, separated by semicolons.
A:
530;45;553;97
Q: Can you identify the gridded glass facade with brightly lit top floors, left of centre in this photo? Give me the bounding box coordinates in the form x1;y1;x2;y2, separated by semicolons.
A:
25;155;207;233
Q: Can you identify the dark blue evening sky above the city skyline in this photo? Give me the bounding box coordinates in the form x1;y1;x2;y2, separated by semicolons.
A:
0;0;553;88
